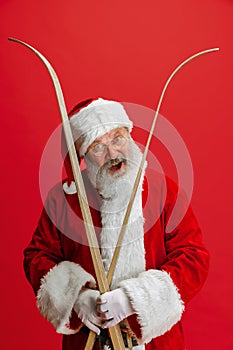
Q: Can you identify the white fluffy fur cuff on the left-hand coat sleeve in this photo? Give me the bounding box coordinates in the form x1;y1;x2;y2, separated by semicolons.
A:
37;261;96;334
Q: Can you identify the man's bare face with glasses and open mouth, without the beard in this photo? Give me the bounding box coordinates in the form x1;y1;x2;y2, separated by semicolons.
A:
85;128;129;176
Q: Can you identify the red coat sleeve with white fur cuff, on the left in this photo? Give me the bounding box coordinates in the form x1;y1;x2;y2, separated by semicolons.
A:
24;190;96;334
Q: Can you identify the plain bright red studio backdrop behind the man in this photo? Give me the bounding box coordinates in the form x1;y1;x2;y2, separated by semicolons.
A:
0;0;233;350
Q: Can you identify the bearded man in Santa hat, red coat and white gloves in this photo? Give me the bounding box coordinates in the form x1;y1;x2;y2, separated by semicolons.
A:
24;98;209;350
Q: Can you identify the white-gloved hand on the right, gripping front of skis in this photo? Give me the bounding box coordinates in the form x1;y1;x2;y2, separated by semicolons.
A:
97;288;134;328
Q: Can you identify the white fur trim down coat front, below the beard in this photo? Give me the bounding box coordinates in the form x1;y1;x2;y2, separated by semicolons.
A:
101;193;146;289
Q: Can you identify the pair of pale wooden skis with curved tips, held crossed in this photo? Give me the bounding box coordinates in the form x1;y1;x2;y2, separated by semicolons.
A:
9;38;219;350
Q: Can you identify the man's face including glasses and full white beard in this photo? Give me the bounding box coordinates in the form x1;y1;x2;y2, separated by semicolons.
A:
80;127;142;198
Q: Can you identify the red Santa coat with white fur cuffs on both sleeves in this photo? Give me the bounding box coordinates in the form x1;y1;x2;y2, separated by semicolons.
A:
24;171;209;350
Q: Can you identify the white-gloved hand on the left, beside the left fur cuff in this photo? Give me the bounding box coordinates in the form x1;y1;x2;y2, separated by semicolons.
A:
74;288;102;334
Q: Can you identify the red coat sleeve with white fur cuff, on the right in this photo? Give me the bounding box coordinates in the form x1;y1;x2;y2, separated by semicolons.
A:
120;176;209;343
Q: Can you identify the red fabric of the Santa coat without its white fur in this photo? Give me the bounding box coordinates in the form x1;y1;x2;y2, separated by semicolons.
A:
24;171;209;350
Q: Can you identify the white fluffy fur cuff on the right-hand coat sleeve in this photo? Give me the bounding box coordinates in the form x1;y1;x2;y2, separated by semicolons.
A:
119;270;184;343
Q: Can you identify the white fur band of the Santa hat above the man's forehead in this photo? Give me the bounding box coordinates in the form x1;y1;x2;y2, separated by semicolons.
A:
70;98;133;157
